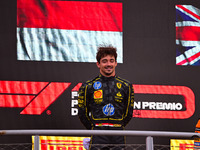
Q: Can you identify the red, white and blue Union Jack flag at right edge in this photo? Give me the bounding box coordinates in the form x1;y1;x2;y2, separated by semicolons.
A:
176;5;200;66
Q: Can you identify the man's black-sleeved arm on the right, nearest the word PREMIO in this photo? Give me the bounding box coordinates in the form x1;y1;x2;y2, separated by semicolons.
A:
123;84;134;127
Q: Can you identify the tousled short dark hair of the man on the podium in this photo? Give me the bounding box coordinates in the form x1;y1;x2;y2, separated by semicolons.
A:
96;45;117;63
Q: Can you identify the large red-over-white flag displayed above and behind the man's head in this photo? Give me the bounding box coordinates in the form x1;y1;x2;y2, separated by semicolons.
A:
17;0;123;63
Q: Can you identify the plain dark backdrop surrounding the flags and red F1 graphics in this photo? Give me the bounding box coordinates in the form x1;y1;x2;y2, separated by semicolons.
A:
0;0;200;144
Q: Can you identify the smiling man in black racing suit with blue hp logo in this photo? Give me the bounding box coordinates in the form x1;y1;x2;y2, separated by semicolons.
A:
78;46;134;149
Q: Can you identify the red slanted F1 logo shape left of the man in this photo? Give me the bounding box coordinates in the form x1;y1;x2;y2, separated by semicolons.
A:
0;81;71;115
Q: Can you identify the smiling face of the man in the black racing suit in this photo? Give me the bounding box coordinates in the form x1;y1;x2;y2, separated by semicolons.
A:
97;55;117;77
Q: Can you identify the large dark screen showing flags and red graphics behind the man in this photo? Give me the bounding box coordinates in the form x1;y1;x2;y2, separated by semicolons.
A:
0;0;200;144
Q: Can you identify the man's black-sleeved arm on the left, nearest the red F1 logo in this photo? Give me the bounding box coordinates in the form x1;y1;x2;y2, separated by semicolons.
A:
78;84;92;129
